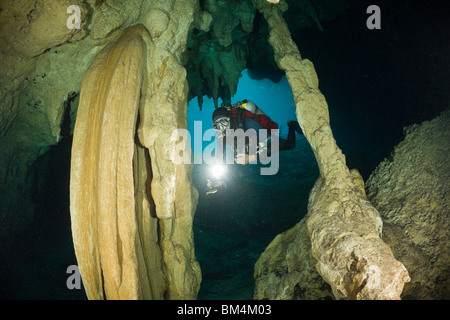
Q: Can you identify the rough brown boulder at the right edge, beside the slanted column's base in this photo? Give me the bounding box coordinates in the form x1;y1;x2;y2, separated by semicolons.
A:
366;111;450;299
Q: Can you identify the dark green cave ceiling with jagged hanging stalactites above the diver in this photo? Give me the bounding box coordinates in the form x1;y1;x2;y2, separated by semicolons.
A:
183;0;351;108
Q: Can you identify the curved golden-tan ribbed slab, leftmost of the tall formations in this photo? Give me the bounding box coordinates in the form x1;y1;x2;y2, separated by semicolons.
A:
70;27;148;299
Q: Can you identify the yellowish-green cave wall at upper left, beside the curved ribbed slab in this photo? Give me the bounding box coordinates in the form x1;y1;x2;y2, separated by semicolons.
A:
0;0;128;243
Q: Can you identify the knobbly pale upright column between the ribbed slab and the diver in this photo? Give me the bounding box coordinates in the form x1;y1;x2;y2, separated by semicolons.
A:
138;0;201;299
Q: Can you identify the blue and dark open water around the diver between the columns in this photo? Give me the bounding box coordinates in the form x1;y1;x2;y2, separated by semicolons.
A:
187;69;319;300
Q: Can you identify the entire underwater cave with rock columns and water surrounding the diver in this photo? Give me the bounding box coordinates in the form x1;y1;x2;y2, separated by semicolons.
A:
0;0;450;300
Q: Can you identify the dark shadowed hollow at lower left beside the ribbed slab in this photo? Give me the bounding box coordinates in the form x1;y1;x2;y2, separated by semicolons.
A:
0;137;86;300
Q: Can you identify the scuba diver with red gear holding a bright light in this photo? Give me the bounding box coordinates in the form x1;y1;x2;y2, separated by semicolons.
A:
212;100;303;165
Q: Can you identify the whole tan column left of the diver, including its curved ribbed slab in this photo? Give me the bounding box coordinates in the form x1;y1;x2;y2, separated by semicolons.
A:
70;0;201;299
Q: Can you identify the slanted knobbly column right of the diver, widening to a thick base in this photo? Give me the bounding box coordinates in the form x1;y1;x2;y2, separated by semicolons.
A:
253;0;409;299
